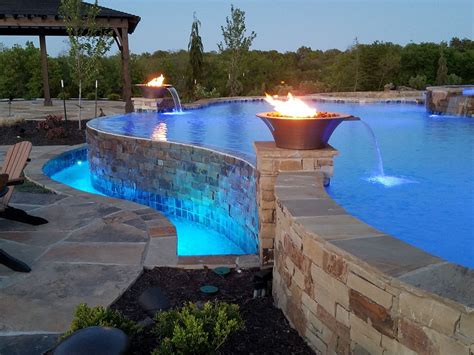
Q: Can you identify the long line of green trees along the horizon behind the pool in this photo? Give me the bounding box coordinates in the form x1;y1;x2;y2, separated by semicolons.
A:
0;11;474;100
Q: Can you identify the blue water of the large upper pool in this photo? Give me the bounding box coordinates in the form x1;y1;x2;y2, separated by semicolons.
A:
54;102;474;267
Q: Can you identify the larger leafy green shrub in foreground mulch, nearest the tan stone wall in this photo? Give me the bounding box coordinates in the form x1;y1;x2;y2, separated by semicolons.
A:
152;302;244;355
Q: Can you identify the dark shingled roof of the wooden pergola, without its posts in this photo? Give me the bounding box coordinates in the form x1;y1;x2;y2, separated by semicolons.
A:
0;0;140;36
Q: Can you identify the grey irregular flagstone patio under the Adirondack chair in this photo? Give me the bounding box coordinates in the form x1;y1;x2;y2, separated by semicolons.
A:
0;146;178;344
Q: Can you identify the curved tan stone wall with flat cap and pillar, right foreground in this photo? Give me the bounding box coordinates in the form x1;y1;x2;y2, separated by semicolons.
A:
256;143;474;355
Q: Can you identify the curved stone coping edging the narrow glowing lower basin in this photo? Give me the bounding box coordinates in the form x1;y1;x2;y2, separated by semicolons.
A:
24;145;259;269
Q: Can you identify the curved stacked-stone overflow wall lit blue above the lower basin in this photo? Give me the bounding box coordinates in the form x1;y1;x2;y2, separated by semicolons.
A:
87;127;258;254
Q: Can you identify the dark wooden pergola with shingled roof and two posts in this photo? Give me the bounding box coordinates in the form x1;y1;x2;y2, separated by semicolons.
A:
0;0;140;112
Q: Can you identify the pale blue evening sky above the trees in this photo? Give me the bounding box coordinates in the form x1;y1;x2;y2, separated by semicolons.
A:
0;0;474;56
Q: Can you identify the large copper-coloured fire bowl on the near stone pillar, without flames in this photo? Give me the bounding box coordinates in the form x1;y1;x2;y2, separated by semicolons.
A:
257;112;360;150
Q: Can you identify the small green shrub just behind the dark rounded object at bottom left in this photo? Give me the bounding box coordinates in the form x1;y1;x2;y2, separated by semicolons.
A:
59;303;141;340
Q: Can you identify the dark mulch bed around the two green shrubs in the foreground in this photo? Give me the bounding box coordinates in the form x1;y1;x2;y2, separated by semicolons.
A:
111;268;313;354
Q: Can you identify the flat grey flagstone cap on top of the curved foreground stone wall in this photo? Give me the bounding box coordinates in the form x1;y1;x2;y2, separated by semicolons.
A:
275;172;474;314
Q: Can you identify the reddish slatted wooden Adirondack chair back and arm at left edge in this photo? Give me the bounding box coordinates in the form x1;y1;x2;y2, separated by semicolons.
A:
0;141;32;211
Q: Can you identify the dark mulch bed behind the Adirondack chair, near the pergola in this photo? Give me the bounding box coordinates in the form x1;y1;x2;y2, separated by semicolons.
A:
0;120;88;146
